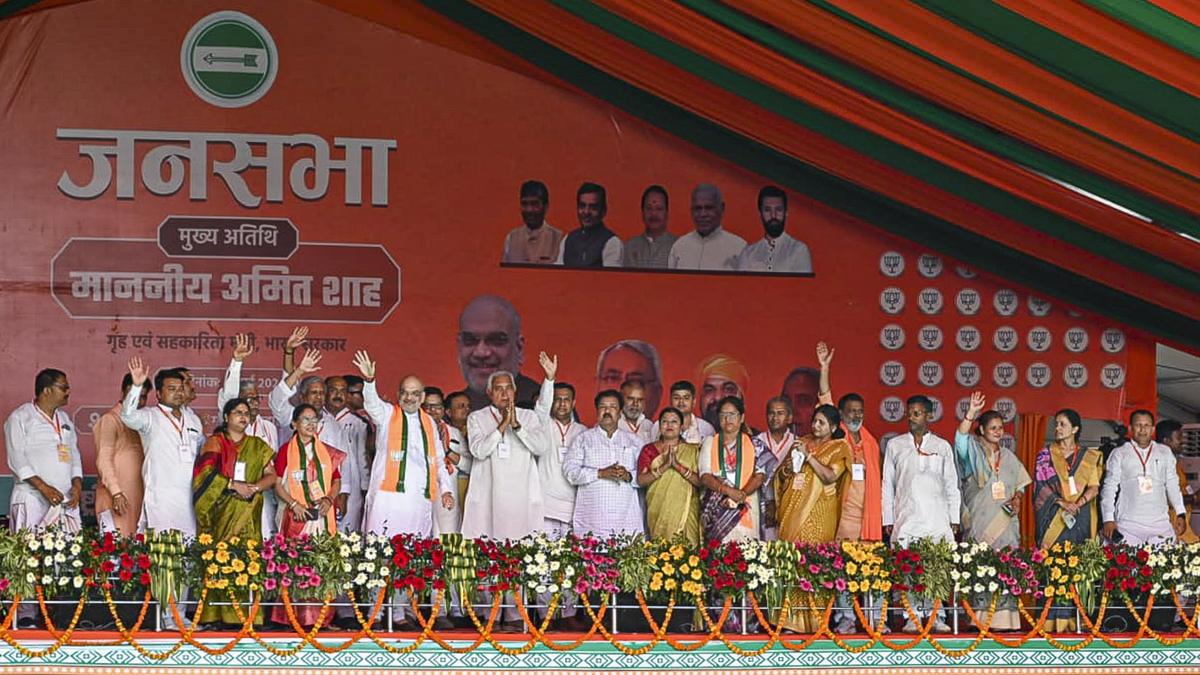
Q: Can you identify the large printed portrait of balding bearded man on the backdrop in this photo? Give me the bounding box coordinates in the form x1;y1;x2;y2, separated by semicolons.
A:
457;294;539;411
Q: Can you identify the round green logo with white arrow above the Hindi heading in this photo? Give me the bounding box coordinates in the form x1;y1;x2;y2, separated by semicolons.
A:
179;11;280;108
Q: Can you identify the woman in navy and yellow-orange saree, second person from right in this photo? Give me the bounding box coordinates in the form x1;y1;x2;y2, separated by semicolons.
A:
1033;408;1104;632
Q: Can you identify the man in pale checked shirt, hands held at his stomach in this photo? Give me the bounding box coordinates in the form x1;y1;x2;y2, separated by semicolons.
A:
563;389;644;537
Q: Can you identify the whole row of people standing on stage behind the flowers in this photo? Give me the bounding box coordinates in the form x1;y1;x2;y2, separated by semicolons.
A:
5;328;1193;631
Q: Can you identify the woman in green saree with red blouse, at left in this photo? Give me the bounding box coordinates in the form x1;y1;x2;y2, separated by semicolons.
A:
192;399;275;626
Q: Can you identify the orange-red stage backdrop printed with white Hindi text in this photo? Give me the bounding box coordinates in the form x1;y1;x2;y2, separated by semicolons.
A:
0;0;1152;478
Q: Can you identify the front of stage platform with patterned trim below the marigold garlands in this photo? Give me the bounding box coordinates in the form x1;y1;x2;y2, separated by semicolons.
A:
0;631;1200;675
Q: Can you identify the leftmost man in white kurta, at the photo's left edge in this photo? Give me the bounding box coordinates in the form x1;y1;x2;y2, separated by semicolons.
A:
4;369;83;627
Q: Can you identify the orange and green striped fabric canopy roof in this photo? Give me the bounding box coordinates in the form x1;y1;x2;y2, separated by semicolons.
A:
9;0;1200;352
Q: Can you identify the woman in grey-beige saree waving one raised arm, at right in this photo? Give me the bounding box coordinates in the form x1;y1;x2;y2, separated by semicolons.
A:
954;392;1031;631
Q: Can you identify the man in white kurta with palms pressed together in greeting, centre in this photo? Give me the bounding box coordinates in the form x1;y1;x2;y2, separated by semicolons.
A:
462;370;551;633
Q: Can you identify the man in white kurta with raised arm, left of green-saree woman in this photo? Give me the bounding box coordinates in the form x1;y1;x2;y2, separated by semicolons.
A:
121;357;204;629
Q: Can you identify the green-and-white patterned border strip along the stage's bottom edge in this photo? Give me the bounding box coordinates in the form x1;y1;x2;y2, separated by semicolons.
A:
0;638;1200;675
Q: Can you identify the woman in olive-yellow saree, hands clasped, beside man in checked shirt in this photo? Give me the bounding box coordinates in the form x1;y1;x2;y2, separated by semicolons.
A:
637;407;700;546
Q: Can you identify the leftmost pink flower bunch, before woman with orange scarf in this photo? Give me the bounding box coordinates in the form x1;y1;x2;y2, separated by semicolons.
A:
259;534;346;598
